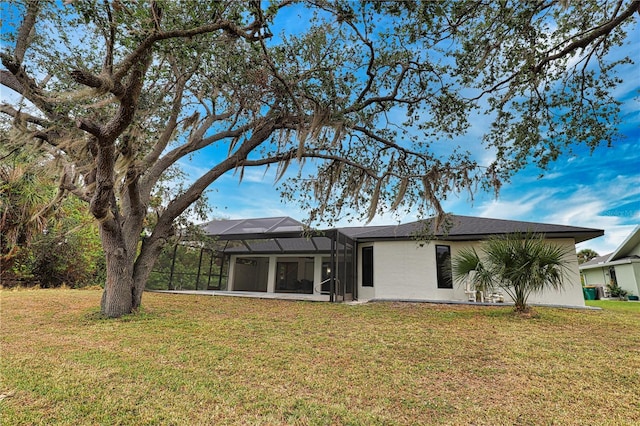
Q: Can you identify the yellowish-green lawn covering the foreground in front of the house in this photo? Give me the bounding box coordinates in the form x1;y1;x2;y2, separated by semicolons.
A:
0;290;640;425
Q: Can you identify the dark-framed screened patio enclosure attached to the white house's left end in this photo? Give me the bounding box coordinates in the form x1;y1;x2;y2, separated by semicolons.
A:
202;217;356;302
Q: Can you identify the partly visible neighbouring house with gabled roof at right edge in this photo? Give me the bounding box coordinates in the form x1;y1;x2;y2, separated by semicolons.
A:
580;225;640;296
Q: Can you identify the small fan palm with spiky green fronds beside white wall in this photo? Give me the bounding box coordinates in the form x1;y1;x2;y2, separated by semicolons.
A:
453;233;570;312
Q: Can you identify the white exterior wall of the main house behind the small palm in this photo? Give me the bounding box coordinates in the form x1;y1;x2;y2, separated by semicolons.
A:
358;239;584;306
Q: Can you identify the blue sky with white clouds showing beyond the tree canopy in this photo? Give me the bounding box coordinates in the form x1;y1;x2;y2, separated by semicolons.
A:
196;15;640;255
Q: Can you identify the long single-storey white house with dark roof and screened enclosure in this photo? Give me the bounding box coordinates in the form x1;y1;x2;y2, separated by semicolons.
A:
203;216;604;306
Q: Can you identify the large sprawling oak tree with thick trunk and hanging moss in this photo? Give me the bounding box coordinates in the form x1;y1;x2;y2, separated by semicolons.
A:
0;0;640;317
